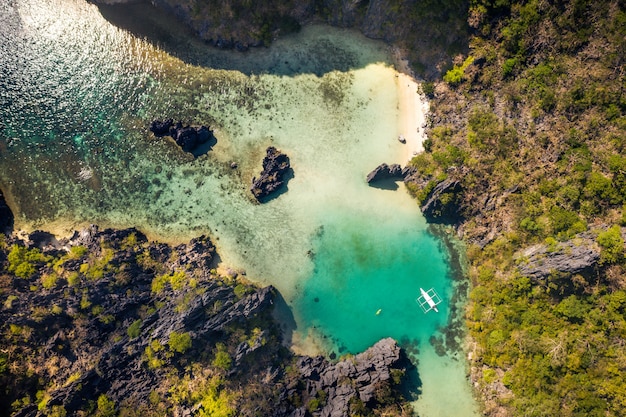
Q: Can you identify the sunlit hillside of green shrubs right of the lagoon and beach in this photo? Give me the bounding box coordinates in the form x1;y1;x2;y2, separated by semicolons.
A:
410;0;626;416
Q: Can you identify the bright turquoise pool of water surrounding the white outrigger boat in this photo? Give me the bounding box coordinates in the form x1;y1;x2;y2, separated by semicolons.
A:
296;206;449;354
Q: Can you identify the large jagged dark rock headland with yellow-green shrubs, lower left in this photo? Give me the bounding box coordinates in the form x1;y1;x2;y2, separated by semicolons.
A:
0;226;410;417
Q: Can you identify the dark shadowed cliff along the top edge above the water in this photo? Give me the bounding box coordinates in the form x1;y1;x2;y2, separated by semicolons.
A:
94;0;458;78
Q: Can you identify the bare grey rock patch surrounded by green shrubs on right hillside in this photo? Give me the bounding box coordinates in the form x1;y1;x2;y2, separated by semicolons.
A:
516;233;600;280
